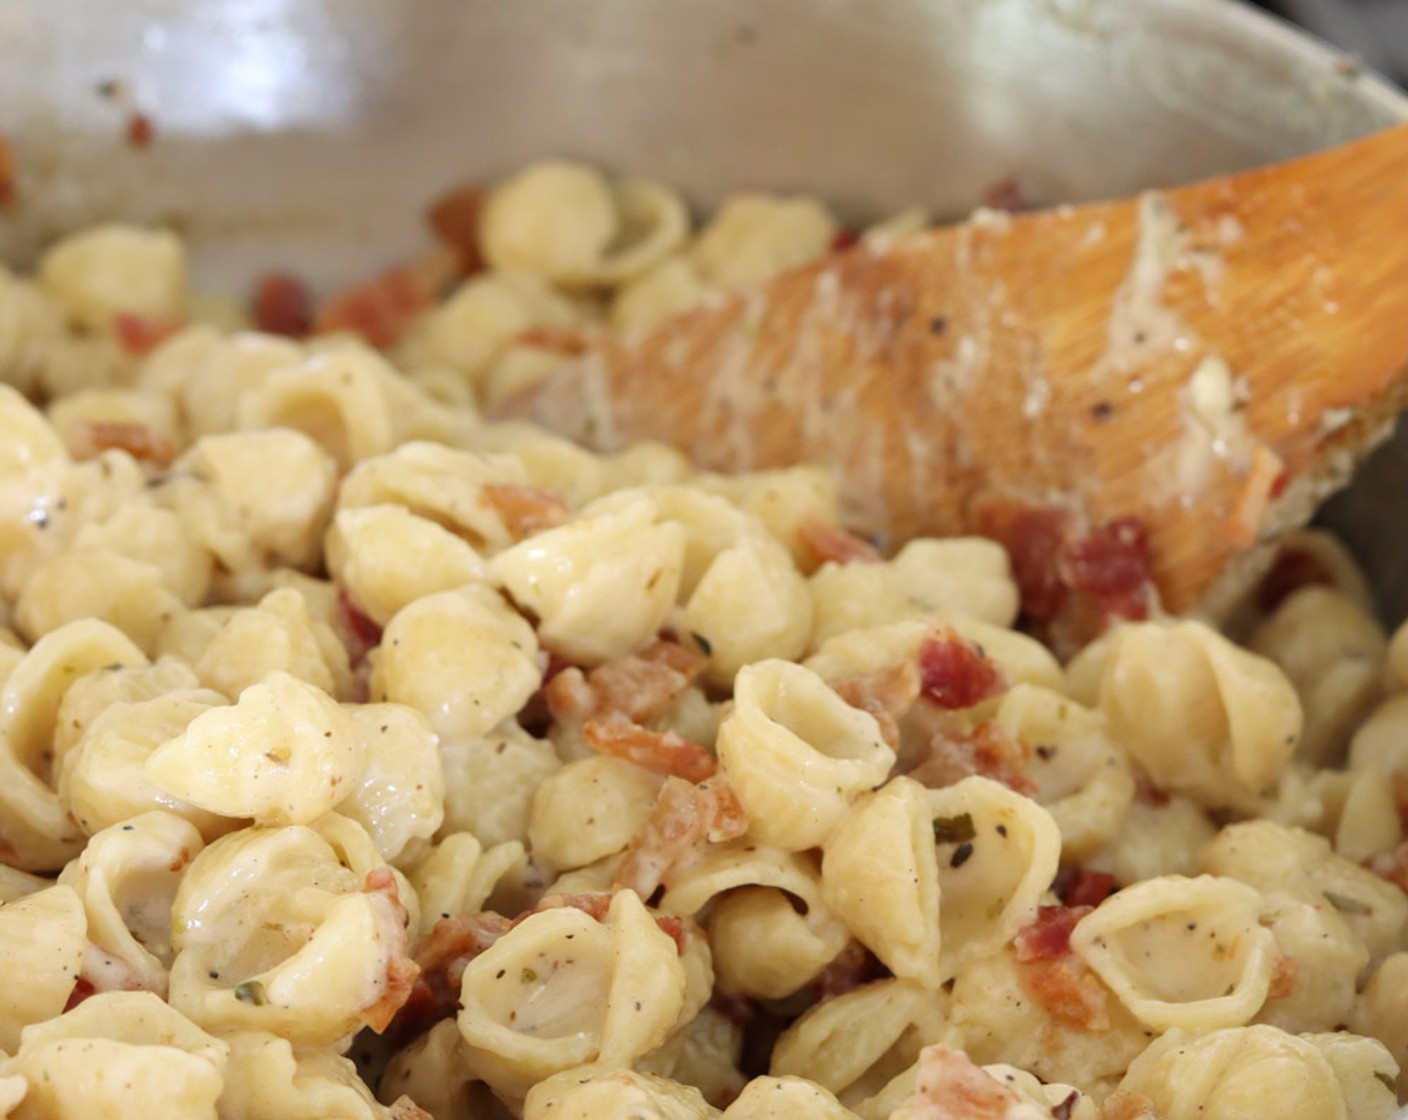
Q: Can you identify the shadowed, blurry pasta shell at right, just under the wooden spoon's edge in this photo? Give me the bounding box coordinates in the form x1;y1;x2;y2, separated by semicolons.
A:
1247;586;1388;766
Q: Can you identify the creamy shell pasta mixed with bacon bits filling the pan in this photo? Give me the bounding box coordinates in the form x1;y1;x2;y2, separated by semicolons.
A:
0;161;1408;1120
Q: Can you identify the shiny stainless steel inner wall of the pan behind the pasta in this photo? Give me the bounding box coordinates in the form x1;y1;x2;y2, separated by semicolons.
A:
0;0;1408;617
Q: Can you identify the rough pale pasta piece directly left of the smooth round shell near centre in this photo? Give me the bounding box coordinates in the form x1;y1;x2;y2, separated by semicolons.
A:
439;720;562;844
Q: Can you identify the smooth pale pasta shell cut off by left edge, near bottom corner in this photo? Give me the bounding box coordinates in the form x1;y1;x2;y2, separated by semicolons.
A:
0;886;87;1052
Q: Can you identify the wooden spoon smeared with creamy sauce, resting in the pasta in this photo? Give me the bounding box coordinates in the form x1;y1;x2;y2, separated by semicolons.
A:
505;125;1408;613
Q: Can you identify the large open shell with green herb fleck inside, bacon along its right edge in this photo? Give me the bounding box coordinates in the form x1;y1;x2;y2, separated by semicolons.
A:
170;820;414;1047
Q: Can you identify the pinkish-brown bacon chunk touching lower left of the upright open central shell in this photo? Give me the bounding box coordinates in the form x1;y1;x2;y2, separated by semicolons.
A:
615;776;748;899
